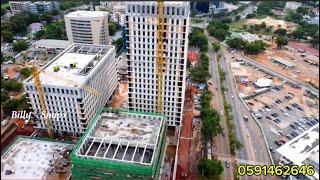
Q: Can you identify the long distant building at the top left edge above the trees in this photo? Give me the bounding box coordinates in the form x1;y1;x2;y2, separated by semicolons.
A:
9;1;60;14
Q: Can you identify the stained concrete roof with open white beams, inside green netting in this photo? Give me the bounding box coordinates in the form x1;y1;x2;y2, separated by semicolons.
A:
75;108;164;165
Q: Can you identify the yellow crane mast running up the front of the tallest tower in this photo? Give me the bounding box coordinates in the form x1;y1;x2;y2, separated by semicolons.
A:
157;0;164;113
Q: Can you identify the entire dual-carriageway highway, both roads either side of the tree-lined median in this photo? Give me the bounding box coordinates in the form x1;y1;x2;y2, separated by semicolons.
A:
205;31;271;179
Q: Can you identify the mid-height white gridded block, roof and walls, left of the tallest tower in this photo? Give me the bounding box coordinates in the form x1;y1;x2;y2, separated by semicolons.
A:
24;44;118;135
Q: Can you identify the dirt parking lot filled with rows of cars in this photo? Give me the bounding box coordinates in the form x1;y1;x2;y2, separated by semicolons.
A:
245;84;319;162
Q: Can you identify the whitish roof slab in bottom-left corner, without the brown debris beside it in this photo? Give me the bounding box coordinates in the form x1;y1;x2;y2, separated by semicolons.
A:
1;138;72;179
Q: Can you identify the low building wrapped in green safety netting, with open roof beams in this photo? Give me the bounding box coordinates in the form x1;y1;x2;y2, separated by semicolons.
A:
71;108;167;180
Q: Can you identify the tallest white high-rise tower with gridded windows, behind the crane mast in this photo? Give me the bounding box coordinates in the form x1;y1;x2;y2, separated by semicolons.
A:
126;1;190;126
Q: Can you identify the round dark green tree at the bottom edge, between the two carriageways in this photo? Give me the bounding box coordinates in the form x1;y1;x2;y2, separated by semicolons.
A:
198;158;223;179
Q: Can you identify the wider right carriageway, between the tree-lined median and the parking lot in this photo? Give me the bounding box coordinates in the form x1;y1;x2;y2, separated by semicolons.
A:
220;47;271;179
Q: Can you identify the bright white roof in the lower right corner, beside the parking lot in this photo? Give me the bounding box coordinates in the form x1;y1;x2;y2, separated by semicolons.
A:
277;124;319;179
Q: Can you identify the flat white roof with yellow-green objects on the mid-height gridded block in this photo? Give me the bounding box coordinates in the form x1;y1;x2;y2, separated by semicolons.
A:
25;44;114;87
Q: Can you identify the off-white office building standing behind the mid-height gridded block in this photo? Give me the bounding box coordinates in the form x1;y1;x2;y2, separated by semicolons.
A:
64;11;110;45
